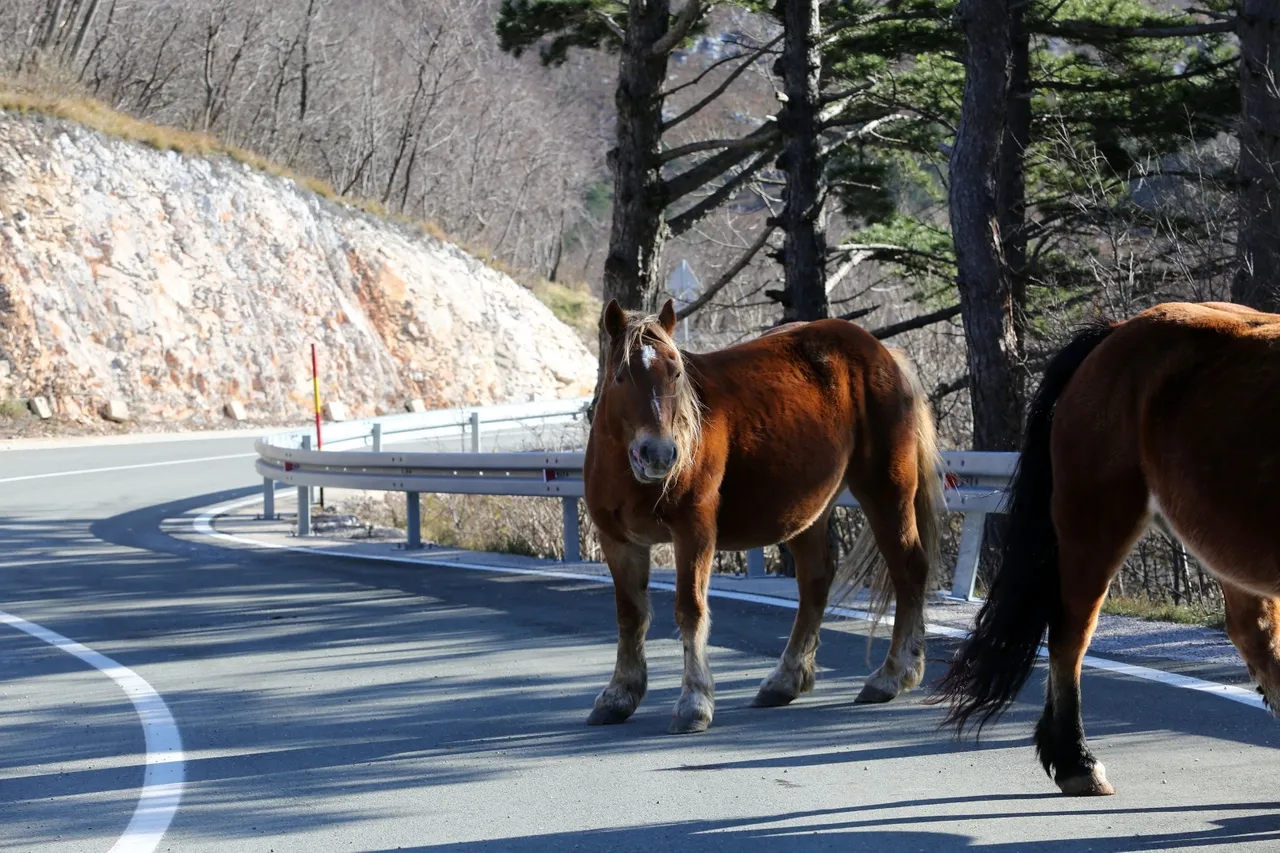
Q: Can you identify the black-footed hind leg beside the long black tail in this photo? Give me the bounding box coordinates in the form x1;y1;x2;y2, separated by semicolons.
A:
1036;465;1148;795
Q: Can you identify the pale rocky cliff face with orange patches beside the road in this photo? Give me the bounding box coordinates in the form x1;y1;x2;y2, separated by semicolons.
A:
0;111;595;425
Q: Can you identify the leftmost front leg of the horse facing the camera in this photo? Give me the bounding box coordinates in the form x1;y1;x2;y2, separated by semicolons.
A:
586;533;650;726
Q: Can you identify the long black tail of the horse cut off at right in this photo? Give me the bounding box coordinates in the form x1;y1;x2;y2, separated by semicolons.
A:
933;323;1115;735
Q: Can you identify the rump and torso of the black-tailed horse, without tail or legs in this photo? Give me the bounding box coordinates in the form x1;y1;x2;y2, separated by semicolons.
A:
1053;298;1280;584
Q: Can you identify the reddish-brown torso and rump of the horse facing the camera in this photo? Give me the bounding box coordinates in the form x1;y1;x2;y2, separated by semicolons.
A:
692;319;914;548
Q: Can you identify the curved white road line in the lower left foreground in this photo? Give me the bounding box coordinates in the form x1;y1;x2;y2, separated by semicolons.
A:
0;610;186;853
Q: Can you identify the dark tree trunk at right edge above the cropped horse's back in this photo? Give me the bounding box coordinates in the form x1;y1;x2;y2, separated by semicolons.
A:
1231;0;1280;311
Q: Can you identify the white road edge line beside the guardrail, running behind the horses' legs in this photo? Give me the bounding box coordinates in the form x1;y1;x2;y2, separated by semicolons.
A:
191;494;1270;713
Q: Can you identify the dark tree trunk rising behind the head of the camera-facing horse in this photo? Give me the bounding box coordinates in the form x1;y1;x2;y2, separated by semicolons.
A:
593;0;671;410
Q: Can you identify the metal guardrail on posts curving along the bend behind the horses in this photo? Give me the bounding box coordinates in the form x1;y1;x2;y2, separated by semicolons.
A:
255;398;1018;599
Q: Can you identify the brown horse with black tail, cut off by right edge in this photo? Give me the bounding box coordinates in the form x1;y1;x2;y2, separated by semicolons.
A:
933;302;1280;795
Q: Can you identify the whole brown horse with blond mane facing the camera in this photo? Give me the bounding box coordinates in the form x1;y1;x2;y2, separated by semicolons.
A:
584;300;942;733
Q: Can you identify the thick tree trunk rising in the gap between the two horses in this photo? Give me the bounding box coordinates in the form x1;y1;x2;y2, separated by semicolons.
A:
948;0;1021;451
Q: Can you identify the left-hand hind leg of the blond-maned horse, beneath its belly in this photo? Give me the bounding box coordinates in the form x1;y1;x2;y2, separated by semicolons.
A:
751;510;836;707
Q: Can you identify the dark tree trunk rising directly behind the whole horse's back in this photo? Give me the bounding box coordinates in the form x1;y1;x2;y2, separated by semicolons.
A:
771;0;829;323
